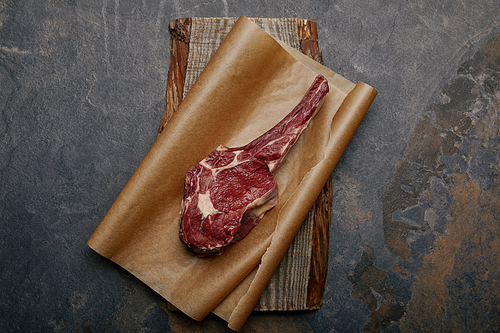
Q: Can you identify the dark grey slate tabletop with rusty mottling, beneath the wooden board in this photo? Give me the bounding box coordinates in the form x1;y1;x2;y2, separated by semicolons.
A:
0;0;500;332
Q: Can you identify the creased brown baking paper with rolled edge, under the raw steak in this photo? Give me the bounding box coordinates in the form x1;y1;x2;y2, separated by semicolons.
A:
88;16;376;330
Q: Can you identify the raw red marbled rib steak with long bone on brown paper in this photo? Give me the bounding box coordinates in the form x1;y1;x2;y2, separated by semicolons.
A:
180;75;329;257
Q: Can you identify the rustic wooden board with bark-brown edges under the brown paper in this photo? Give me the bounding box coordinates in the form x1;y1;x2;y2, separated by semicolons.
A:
158;18;332;311
